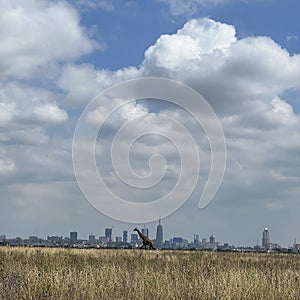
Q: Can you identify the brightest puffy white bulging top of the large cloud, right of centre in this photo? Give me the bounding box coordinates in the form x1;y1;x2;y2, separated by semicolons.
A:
144;18;236;78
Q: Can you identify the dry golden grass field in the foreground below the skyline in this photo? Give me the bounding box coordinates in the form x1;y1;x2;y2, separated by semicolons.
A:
0;247;300;300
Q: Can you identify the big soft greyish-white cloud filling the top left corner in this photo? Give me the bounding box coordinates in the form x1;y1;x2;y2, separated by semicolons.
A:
0;0;100;79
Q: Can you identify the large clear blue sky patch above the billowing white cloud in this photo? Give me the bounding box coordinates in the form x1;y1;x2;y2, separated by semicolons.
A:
82;0;300;70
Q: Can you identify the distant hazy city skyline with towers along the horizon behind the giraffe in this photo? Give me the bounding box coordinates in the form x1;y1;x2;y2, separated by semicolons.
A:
0;220;300;253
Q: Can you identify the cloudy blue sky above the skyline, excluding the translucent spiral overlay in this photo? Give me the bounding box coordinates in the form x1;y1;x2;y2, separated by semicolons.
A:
0;0;300;246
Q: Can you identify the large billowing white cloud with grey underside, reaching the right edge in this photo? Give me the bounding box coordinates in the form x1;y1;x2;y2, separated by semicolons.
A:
143;18;300;117
